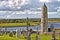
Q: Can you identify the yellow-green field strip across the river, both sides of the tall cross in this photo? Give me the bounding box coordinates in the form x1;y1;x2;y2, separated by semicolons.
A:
0;22;38;27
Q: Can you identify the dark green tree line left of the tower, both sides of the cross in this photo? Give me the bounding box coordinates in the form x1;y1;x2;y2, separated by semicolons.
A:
0;19;39;23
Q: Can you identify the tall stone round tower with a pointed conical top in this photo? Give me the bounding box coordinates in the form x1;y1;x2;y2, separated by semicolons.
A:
41;3;48;34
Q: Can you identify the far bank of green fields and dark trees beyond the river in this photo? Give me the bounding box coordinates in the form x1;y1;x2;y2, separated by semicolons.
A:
0;18;60;27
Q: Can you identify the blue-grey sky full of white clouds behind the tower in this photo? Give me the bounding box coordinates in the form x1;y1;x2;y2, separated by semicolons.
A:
0;0;60;19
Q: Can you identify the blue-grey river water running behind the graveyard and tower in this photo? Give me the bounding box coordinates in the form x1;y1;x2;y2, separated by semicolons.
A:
0;22;60;31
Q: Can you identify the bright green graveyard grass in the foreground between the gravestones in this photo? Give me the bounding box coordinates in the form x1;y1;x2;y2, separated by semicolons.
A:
0;34;60;40
